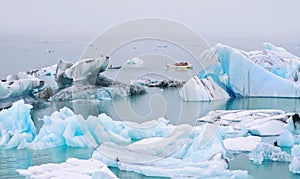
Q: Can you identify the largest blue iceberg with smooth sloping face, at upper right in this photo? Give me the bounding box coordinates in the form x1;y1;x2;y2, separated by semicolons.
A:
186;43;300;100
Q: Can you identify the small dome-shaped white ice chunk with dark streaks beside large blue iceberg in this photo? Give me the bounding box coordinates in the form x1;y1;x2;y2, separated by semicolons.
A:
180;76;230;101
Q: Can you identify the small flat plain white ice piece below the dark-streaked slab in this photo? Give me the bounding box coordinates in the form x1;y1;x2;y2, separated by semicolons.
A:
223;136;262;151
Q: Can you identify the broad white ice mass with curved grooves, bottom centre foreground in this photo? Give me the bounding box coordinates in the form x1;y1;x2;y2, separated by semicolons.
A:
92;124;248;178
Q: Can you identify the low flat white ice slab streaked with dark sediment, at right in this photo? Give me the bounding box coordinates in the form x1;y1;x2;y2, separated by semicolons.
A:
197;109;291;138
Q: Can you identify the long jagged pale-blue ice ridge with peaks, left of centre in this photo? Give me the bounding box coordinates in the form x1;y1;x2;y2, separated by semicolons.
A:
29;107;173;150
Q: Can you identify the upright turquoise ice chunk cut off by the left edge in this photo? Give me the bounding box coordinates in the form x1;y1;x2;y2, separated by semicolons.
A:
0;100;36;148
